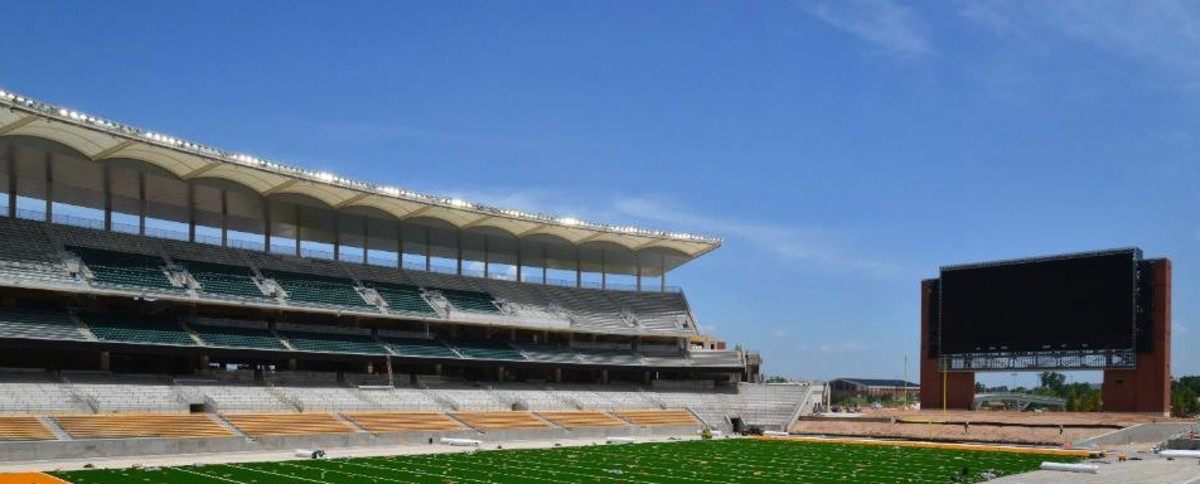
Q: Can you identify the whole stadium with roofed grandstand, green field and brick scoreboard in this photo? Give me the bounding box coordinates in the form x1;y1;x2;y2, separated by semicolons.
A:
0;87;1190;484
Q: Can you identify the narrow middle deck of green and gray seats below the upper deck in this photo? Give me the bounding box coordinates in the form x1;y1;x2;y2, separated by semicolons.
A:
0;307;743;368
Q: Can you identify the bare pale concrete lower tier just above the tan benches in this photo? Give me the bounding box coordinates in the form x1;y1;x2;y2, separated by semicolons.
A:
0;370;823;429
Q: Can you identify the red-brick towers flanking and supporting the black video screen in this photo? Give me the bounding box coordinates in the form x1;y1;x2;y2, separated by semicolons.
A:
920;258;1171;414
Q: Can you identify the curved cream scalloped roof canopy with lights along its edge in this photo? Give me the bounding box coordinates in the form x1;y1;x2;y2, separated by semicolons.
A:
0;90;721;263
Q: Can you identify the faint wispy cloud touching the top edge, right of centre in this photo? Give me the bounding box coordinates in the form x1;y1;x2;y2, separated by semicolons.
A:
800;0;932;56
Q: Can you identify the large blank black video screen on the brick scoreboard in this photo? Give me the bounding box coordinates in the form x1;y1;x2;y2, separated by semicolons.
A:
937;249;1141;354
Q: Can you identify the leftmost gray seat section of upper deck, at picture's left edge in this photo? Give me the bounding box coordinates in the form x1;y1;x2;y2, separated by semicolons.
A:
0;217;73;282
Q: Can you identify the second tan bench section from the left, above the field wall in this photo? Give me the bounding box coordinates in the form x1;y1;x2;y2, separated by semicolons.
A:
54;413;234;438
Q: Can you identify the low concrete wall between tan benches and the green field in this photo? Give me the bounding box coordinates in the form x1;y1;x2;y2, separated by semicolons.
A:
0;425;698;461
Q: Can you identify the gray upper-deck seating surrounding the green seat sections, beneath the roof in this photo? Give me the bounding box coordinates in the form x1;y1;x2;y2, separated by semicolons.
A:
0;217;697;335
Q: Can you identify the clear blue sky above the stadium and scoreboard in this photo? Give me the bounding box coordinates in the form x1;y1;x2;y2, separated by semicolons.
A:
0;0;1200;383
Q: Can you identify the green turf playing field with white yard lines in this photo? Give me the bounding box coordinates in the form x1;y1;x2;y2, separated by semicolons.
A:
54;440;1076;484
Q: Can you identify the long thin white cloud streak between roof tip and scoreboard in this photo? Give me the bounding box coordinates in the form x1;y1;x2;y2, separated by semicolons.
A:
614;196;902;276
